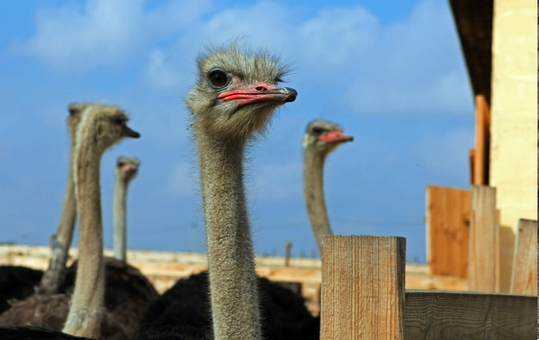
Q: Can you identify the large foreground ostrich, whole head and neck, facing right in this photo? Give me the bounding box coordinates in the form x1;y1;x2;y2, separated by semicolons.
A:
190;43;297;339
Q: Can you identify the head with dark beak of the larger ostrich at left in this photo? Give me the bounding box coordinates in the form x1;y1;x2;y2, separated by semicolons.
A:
77;105;140;155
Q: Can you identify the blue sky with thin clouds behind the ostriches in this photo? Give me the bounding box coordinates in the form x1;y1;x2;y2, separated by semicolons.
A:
0;0;474;261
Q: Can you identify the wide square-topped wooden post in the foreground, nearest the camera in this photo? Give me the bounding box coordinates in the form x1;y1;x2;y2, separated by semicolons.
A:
320;235;406;340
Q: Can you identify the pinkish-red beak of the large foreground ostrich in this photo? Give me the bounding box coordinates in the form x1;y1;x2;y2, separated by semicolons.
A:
217;83;298;106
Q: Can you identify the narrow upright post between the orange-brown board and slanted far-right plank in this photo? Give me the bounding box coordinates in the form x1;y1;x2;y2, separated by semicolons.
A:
468;186;500;293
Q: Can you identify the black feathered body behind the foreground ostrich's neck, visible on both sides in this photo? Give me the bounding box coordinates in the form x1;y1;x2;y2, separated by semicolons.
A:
136;272;320;340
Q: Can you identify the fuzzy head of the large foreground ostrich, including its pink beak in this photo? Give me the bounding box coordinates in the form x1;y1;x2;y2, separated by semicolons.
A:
186;43;297;143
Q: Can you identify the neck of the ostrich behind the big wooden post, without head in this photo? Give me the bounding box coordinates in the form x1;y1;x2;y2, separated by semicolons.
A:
303;149;333;254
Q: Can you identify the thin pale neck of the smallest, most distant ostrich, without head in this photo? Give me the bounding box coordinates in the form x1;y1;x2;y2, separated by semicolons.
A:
112;173;129;261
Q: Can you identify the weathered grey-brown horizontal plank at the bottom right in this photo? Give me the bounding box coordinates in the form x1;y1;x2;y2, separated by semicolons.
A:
404;290;537;340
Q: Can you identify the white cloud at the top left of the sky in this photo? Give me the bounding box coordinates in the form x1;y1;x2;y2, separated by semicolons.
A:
15;0;211;72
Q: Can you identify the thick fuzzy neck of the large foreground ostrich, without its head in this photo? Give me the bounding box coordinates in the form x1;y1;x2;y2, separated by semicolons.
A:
197;134;261;340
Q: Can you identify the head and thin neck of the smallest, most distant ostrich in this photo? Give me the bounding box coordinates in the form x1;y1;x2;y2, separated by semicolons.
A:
112;157;140;261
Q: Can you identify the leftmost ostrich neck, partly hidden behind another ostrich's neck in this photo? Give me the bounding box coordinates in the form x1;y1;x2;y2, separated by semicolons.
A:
37;145;77;295
